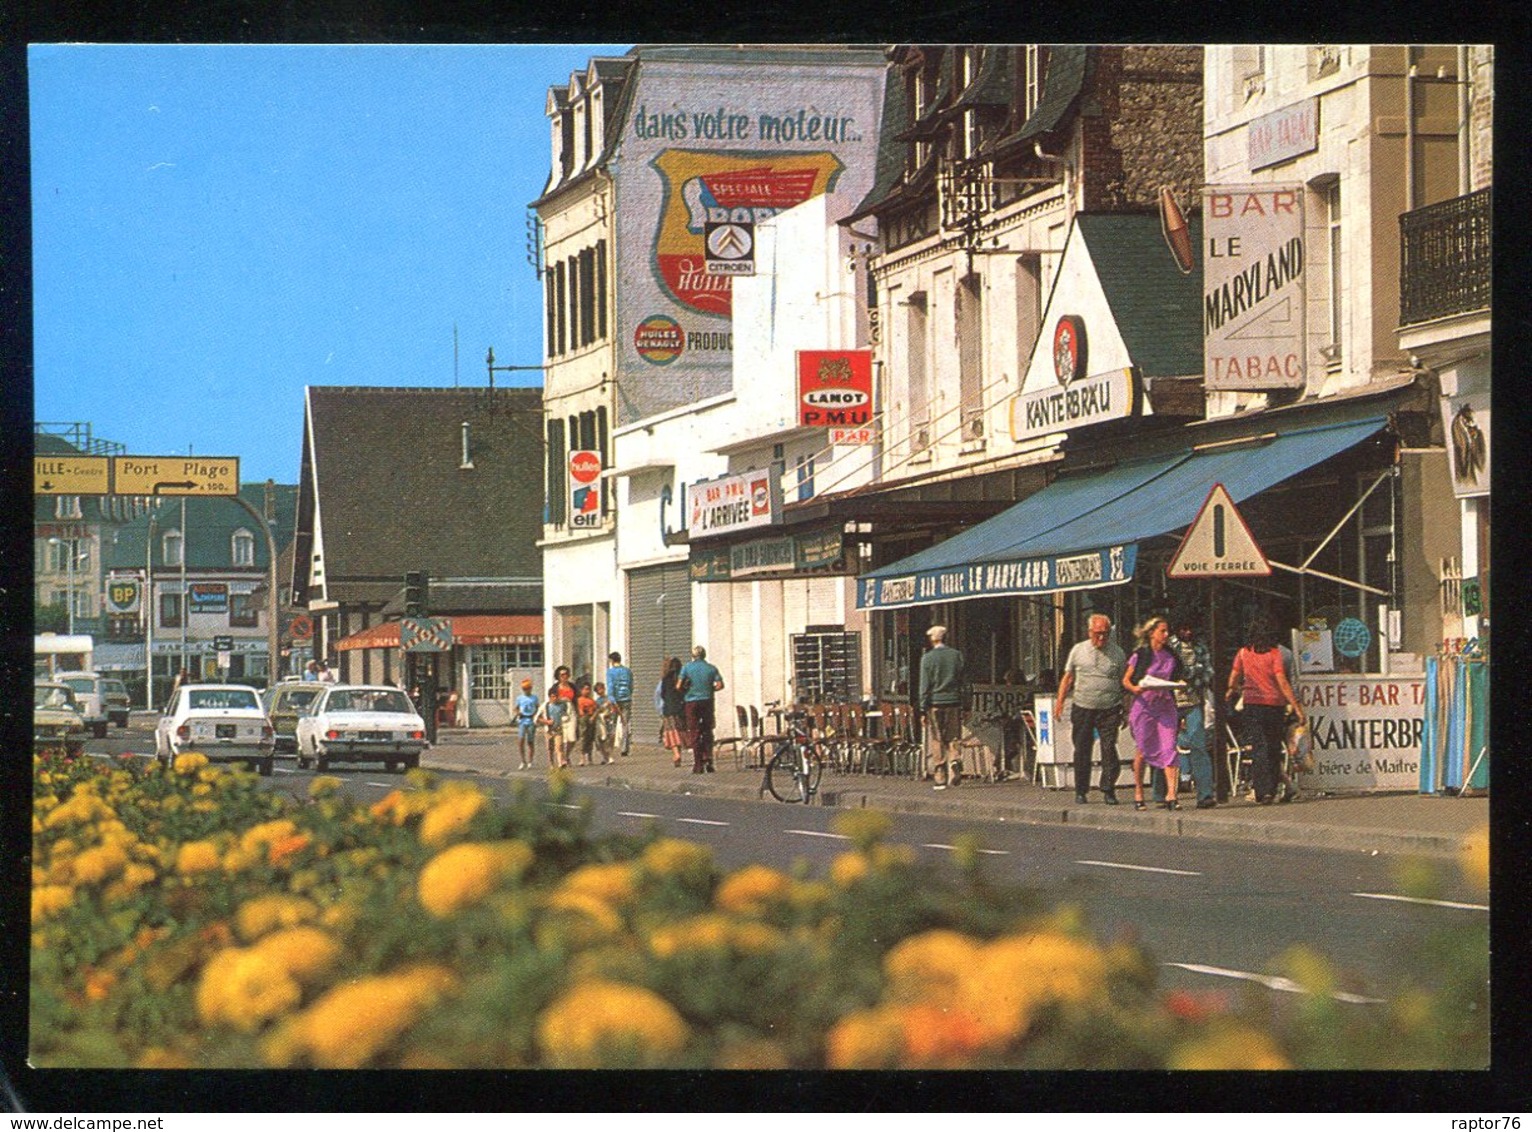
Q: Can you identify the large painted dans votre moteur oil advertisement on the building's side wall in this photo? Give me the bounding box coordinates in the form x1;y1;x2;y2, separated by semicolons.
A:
616;49;884;421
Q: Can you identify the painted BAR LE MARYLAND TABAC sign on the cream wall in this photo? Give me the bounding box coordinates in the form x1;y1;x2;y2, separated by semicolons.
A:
1203;185;1307;389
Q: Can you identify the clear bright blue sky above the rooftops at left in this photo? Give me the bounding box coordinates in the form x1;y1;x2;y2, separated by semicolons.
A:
28;44;627;483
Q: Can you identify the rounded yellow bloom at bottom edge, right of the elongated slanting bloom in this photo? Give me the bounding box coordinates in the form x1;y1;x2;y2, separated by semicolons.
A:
538;982;689;1069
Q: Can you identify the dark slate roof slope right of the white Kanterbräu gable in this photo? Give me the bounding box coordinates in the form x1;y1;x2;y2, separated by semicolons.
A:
1074;213;1203;377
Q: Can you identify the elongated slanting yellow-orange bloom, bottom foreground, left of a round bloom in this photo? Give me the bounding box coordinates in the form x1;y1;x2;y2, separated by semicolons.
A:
264;967;457;1069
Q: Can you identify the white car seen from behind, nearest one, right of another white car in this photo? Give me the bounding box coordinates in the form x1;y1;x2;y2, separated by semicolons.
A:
297;683;427;770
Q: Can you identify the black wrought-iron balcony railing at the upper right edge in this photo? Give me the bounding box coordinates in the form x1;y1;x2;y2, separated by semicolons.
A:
1399;188;1491;326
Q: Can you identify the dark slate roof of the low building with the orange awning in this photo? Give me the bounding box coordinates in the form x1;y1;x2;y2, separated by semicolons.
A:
294;386;544;608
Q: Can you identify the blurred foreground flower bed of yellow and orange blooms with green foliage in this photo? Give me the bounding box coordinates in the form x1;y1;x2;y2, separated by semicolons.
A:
31;754;1488;1069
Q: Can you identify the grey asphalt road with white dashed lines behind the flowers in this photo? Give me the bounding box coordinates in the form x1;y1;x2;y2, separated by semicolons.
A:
87;723;1488;1009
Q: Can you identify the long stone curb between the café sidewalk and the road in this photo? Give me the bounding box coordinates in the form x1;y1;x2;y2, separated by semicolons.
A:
429;760;1462;856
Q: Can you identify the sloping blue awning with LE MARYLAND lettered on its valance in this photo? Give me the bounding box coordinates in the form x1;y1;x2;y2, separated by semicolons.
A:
856;417;1386;610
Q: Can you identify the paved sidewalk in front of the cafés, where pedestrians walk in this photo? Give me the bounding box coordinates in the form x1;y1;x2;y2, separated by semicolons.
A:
421;728;1489;856
